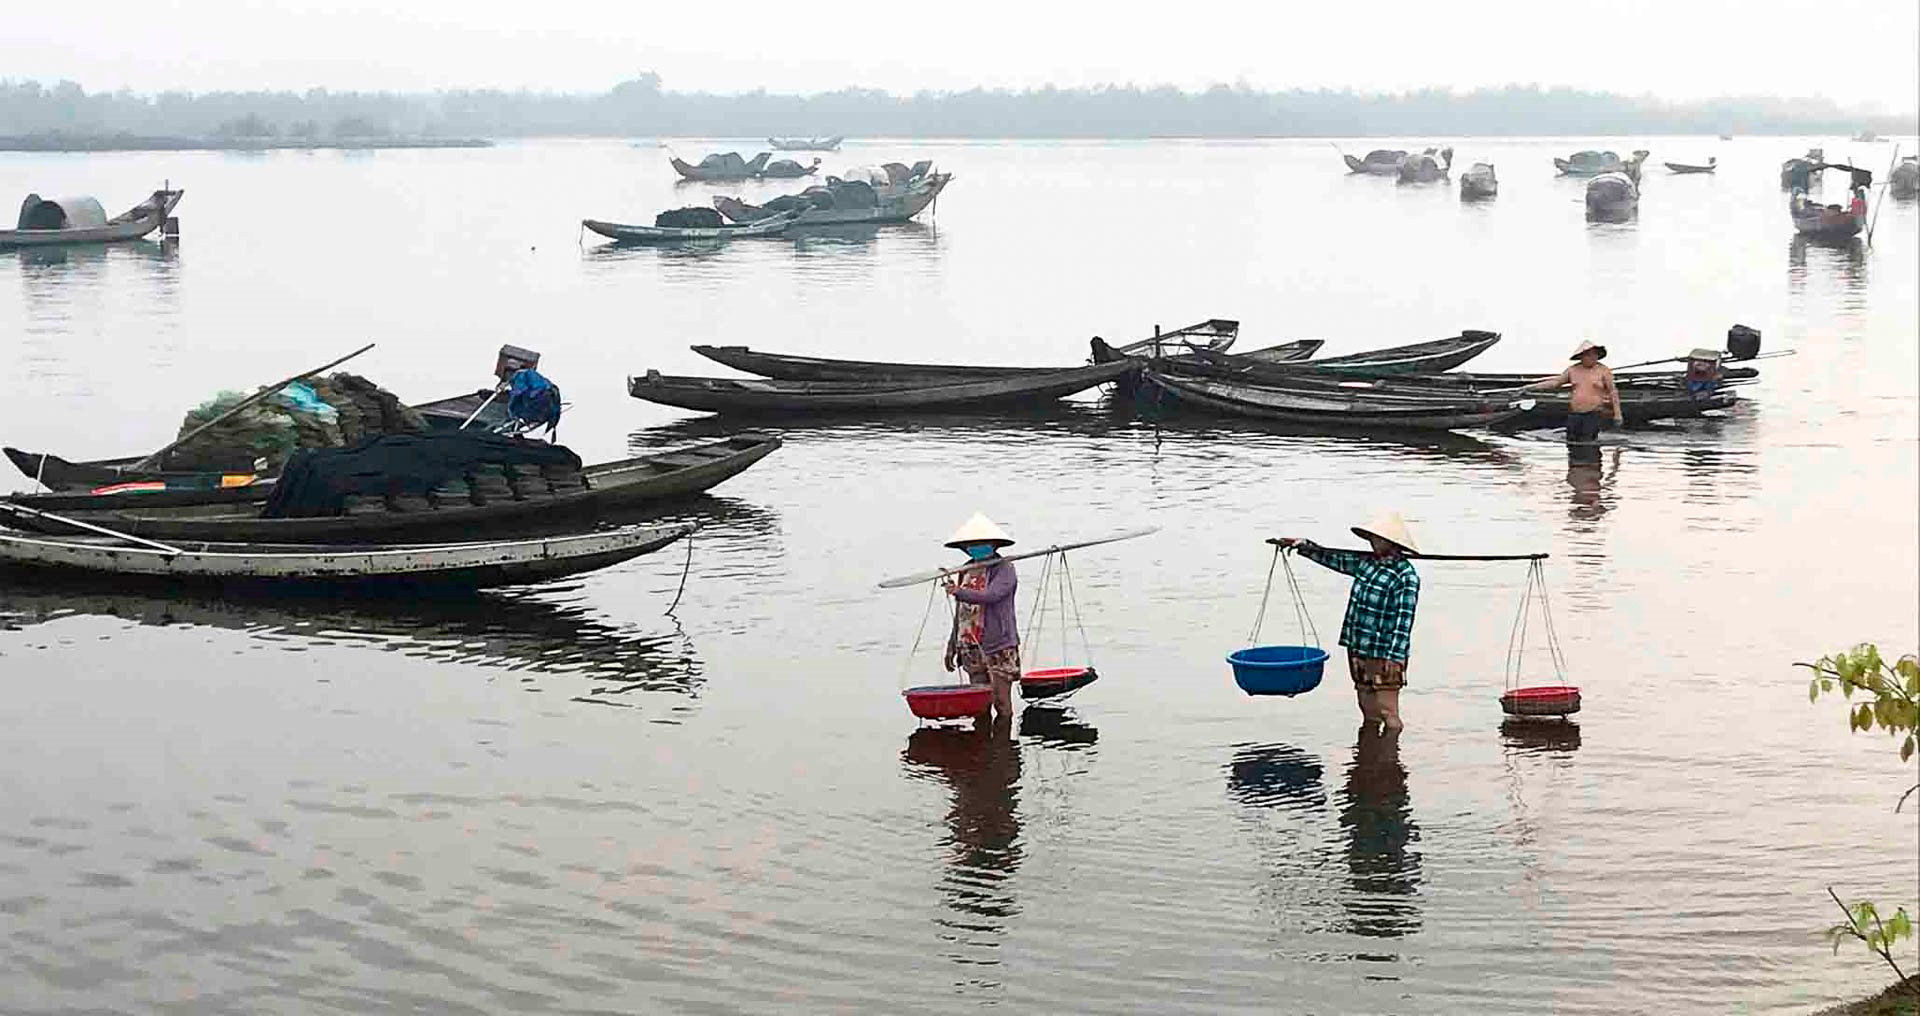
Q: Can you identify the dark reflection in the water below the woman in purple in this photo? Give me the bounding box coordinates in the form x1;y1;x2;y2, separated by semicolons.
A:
902;716;1021;931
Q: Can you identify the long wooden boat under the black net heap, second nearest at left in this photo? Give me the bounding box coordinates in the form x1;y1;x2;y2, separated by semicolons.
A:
0;432;781;544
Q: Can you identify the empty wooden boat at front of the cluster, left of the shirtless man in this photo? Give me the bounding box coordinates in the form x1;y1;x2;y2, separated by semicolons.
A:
1142;371;1528;430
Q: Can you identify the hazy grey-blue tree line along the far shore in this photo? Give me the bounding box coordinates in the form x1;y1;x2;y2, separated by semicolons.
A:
0;73;1914;138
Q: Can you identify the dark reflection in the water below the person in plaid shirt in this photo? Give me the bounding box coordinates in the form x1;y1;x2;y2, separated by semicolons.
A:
1340;726;1421;939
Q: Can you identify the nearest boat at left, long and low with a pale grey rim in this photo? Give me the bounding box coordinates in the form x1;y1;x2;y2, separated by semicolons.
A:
0;524;693;593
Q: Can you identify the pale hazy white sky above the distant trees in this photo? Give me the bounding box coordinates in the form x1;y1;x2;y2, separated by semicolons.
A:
0;0;1920;111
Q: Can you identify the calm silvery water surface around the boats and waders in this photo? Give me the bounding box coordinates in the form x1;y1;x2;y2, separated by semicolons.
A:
0;138;1920;1012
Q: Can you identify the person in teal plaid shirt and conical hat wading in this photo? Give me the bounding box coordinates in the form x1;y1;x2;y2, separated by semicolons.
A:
1281;511;1421;734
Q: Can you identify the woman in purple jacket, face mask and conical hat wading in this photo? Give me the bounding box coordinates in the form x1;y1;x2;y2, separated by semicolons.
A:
945;513;1020;718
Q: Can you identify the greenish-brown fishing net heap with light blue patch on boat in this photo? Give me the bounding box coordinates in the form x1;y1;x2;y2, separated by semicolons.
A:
167;373;426;472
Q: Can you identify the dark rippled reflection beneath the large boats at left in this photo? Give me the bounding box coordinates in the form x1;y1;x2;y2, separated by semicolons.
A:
0;582;701;697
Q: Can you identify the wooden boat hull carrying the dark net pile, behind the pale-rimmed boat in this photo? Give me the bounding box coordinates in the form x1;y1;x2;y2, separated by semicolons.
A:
10;432;781;544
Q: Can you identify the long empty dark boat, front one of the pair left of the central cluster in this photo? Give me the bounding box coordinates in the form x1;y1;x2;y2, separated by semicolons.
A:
626;359;1140;415
